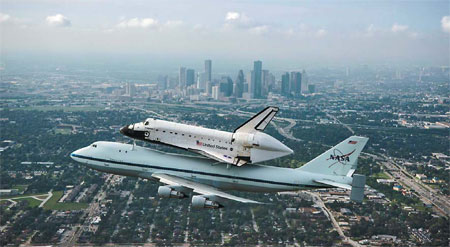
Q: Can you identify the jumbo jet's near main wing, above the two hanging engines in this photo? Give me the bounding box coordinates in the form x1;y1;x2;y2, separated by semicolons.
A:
152;173;262;204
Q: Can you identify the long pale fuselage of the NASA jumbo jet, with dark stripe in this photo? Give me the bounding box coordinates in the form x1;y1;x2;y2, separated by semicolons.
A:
71;142;351;192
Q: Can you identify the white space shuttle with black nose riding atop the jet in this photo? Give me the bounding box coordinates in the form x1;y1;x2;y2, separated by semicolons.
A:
120;106;293;166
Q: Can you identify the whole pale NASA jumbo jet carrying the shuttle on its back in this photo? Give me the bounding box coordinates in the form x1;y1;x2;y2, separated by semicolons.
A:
71;136;368;208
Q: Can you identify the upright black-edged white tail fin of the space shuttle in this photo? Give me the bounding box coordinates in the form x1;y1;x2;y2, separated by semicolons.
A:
234;106;278;133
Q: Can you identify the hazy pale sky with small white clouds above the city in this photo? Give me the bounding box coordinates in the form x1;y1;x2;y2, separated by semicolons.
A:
0;0;450;67
